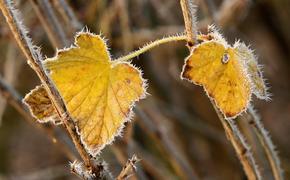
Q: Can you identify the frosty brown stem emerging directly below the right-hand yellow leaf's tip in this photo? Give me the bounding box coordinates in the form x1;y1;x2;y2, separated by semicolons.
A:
211;100;261;179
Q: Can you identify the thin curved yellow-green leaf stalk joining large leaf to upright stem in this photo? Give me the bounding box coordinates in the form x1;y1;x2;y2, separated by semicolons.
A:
113;35;187;62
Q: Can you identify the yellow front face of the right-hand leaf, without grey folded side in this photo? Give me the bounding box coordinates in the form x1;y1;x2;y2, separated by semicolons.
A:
181;39;251;118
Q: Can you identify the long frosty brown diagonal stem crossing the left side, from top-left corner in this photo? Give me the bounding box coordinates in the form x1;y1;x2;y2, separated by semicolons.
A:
0;0;100;176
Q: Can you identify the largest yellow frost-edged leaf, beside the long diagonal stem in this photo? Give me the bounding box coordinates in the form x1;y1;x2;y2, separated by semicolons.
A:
44;33;145;156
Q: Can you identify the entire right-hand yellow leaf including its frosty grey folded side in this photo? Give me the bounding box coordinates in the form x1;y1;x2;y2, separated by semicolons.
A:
181;25;269;118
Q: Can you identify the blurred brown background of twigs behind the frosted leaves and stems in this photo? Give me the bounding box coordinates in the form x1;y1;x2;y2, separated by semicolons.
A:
0;0;290;180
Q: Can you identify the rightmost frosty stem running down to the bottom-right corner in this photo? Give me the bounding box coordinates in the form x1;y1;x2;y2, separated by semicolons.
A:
247;107;284;180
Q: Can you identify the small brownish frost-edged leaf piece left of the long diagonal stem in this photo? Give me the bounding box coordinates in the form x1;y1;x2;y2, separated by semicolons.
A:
23;85;61;124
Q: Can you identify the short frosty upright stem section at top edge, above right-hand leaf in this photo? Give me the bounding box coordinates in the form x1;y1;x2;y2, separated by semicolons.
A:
180;0;197;47
